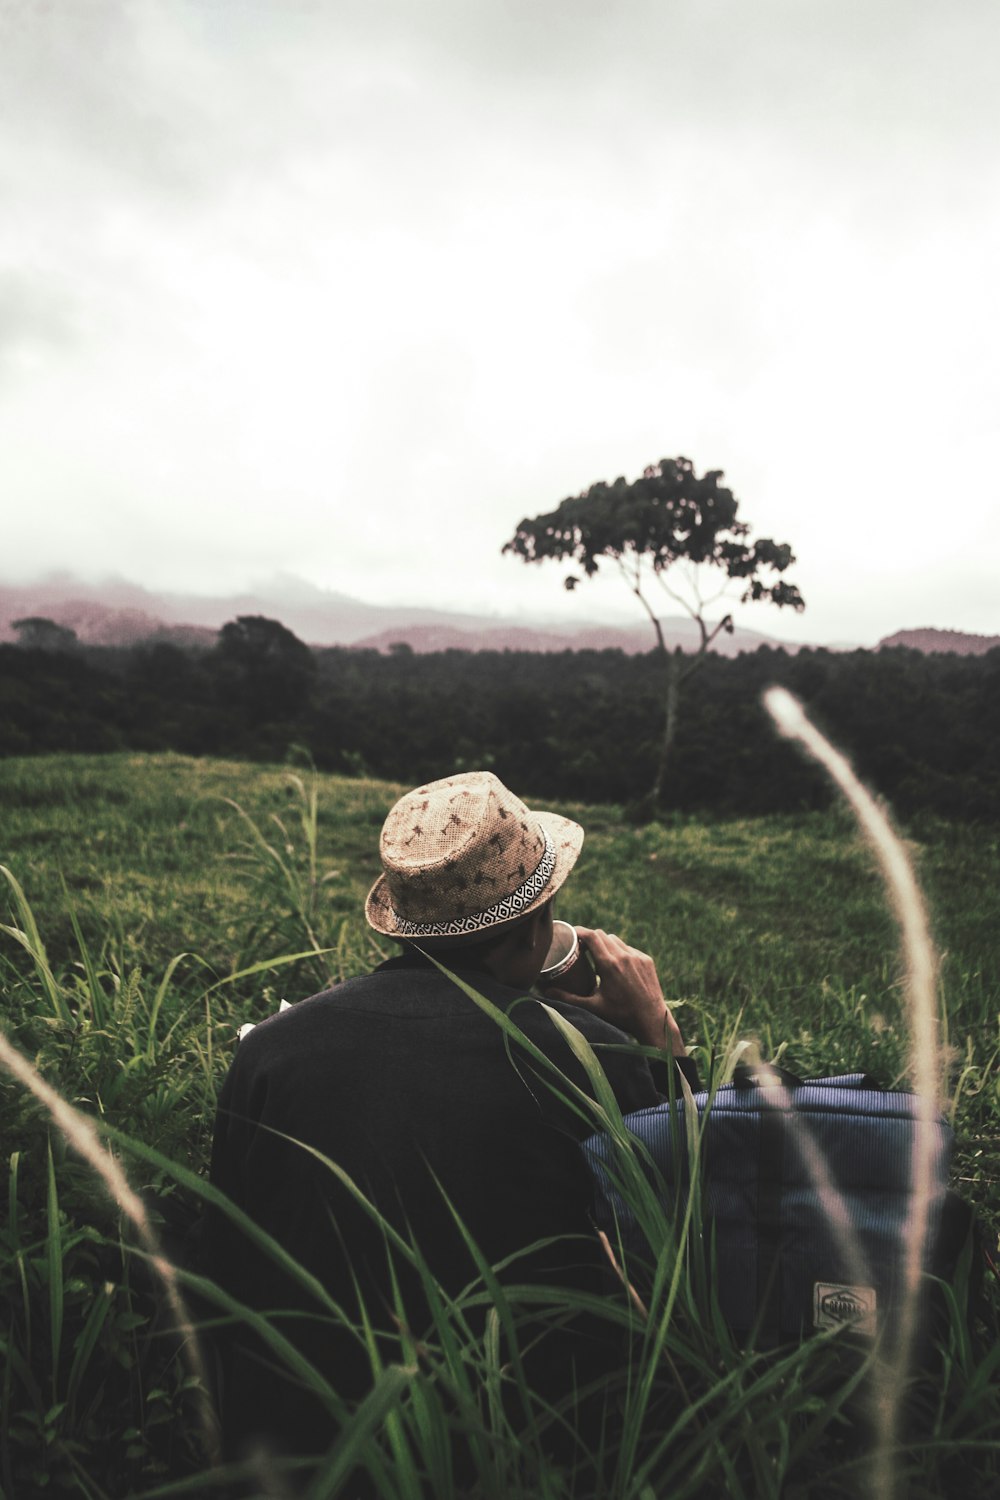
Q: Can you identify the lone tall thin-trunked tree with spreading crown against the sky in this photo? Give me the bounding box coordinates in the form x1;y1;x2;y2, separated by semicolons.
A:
504;458;805;812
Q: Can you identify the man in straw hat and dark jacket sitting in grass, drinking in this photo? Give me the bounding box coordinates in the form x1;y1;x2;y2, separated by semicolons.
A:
204;771;697;1454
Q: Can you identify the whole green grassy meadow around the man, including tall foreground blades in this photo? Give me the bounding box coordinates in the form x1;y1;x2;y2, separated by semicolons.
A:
0;755;1000;1500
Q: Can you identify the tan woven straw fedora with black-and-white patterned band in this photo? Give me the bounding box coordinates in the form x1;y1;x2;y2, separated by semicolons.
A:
364;771;583;939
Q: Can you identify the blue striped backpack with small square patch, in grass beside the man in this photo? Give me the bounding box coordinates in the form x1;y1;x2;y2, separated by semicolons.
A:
585;1067;972;1347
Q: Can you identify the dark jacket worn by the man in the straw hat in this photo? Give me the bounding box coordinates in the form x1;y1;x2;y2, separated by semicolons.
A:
204;957;692;1448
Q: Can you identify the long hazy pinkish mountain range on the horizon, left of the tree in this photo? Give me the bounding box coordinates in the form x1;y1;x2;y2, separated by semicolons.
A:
0;573;798;656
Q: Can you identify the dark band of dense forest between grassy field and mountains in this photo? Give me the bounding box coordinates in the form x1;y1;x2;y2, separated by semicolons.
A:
0;620;1000;822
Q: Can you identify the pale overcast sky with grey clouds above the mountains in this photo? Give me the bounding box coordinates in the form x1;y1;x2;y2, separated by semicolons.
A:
0;0;1000;644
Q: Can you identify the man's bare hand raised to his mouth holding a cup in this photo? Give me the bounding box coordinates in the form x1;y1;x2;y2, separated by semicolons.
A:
546;927;687;1058
